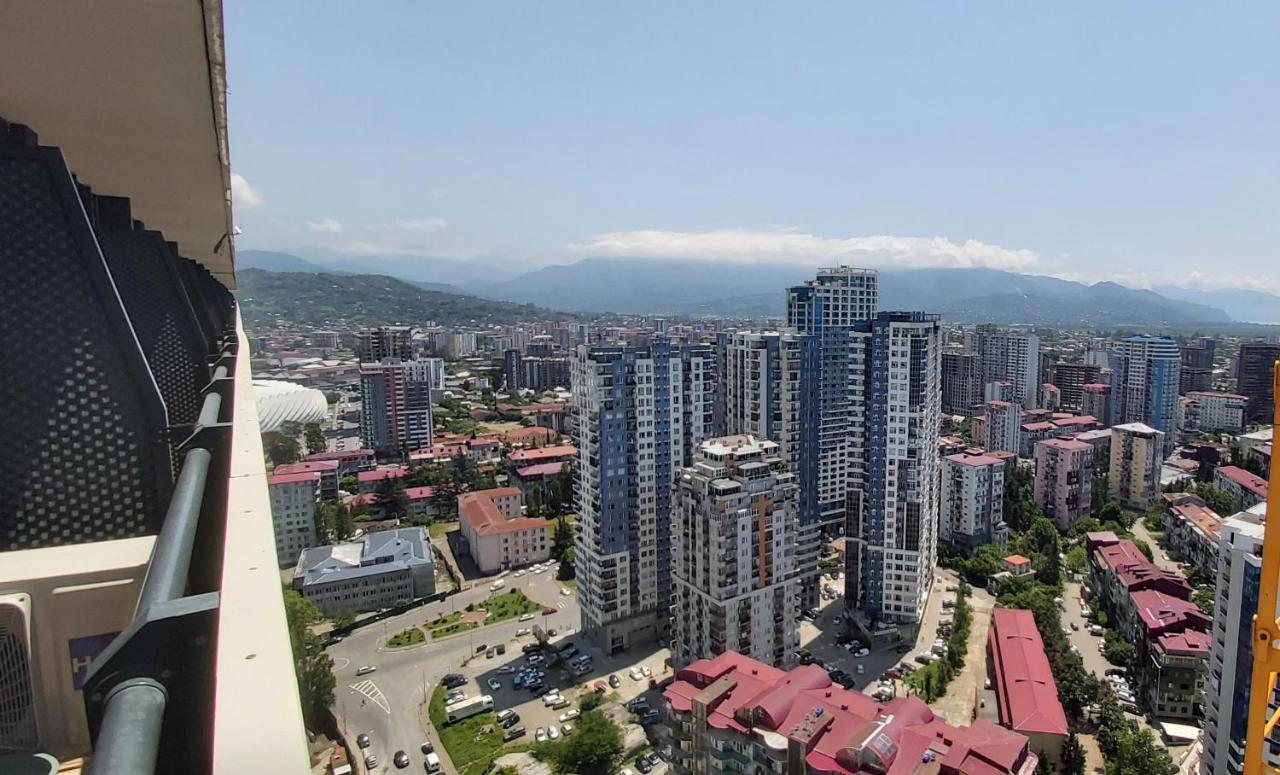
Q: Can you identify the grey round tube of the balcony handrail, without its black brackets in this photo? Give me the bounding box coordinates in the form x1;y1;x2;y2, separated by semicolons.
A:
92;350;234;775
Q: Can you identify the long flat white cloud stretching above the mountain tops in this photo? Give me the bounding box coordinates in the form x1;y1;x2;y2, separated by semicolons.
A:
570;227;1039;270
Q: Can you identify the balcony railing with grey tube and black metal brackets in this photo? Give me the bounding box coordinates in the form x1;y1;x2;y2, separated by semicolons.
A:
84;330;238;775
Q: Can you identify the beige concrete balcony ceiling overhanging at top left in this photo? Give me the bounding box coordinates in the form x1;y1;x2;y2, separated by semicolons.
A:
0;0;236;288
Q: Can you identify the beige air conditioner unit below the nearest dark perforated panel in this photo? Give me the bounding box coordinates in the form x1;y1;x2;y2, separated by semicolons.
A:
0;535;155;761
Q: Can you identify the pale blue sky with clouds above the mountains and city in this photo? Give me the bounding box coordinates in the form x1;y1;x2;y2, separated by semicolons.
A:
225;0;1280;291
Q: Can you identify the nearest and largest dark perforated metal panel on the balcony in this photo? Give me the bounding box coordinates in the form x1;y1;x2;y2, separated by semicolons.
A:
0;142;173;550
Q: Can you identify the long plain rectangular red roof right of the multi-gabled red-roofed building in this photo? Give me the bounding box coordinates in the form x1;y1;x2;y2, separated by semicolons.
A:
987;608;1068;735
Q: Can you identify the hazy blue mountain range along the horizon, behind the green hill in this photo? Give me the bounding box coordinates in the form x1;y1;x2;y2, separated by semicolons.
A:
237;250;1280;327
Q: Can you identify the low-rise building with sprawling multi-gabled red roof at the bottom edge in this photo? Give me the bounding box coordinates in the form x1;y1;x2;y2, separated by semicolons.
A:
663;652;1039;775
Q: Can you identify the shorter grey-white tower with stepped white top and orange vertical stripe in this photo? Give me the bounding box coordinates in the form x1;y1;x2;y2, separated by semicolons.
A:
671;436;800;666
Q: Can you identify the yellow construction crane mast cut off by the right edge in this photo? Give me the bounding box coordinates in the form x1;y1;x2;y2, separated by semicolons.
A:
1244;363;1280;775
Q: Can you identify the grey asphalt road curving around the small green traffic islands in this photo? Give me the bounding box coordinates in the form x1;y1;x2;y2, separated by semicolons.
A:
329;571;580;772
